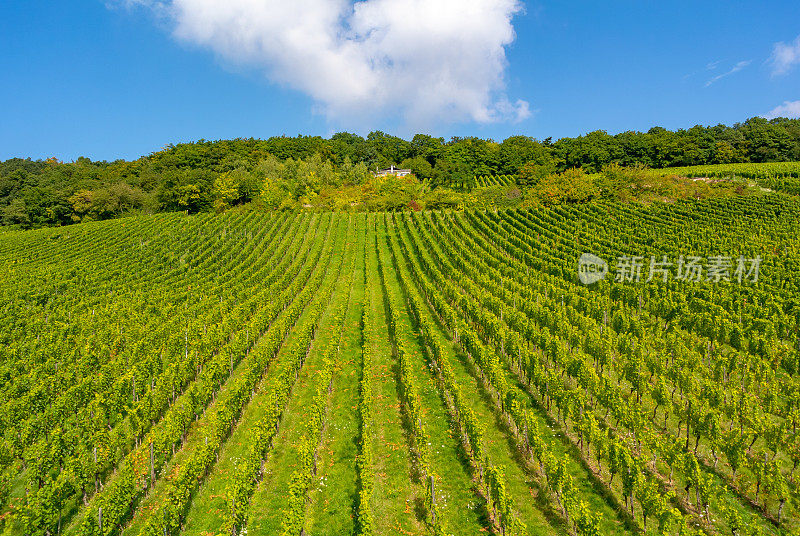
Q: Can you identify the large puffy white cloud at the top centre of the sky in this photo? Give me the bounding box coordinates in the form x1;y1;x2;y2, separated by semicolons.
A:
122;0;531;126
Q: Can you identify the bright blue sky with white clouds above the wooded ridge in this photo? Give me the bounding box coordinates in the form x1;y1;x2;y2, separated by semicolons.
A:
0;0;800;160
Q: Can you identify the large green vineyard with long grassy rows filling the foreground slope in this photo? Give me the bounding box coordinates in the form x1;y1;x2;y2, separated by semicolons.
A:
0;196;800;536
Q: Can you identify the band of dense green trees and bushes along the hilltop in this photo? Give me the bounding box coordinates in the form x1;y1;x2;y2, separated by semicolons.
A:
0;118;800;228
